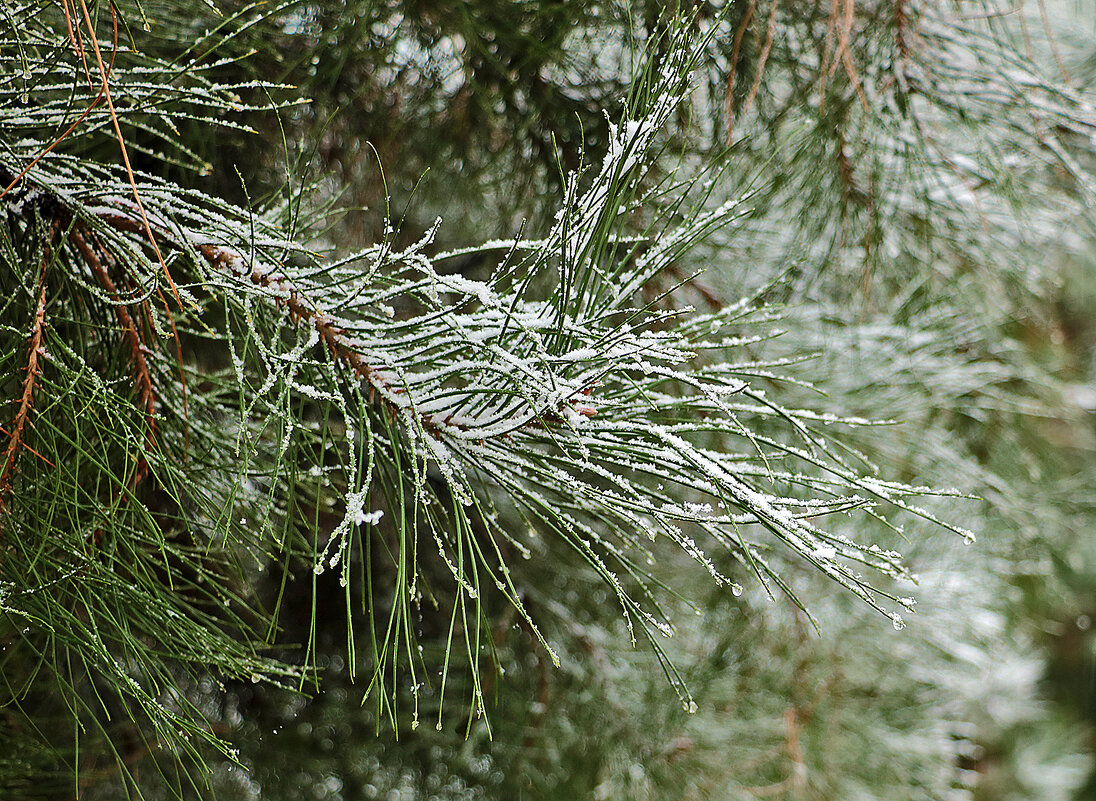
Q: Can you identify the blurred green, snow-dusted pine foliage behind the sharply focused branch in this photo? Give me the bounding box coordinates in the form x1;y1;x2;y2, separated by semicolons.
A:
6;0;1096;801
